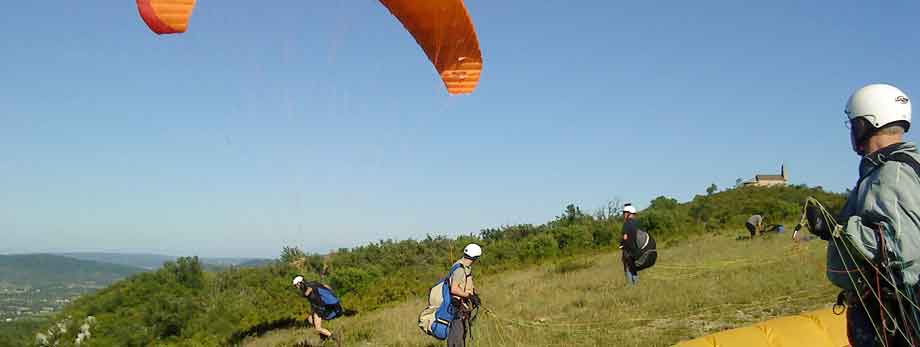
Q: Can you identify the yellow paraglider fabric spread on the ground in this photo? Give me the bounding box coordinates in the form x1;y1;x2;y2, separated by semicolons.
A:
675;309;850;347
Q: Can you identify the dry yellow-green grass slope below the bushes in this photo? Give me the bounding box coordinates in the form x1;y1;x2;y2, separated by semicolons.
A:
243;233;836;347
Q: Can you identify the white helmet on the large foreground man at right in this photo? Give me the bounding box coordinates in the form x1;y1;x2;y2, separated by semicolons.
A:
844;84;911;154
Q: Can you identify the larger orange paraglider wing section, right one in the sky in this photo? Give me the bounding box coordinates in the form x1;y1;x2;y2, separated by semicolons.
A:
380;0;482;94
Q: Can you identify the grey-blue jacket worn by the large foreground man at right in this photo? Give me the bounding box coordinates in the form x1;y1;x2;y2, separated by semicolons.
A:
827;142;920;290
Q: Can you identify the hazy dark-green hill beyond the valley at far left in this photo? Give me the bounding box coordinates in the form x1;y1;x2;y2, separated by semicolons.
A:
0;254;145;288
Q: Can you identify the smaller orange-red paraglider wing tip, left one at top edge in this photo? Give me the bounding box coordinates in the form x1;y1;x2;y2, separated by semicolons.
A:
137;0;195;35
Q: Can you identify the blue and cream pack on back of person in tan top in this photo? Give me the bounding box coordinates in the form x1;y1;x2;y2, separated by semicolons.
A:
418;264;462;340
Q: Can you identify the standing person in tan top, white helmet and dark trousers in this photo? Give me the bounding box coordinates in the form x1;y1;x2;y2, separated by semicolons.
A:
447;243;482;347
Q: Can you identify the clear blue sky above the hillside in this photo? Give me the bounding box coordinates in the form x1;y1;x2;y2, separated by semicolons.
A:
0;0;920;257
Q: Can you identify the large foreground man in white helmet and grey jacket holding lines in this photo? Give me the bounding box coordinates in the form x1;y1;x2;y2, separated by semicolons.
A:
806;84;920;347
